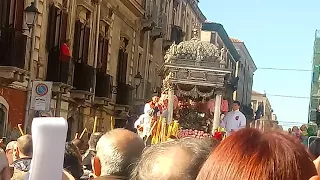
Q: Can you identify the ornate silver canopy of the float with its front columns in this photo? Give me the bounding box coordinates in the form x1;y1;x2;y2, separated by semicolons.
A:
159;28;233;129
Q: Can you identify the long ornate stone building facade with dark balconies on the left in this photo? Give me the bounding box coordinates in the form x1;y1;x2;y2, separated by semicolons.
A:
0;0;205;138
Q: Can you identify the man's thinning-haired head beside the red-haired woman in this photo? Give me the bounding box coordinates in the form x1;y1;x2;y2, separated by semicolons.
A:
131;138;213;180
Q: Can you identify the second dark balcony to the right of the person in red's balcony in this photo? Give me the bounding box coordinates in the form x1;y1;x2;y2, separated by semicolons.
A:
95;71;113;104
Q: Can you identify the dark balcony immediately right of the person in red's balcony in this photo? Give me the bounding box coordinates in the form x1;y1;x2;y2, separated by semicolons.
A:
71;62;94;100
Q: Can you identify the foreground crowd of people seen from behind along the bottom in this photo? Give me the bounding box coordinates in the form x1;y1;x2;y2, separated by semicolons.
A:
0;128;320;180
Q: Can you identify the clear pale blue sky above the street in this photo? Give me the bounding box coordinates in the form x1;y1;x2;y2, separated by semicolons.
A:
199;0;320;128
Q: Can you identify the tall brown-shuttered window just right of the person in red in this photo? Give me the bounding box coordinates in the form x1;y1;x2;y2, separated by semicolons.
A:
73;20;90;64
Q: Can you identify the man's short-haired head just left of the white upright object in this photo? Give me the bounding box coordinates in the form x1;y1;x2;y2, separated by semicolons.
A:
16;134;33;158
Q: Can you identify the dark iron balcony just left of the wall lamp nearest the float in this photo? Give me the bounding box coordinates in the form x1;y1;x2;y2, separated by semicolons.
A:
116;83;133;106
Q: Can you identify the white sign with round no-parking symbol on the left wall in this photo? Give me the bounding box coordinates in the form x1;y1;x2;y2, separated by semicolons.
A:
31;81;52;111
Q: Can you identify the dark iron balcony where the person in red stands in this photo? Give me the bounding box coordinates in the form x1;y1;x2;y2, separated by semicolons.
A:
46;47;73;93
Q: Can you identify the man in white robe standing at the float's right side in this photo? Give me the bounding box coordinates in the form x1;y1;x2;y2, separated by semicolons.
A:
220;101;247;136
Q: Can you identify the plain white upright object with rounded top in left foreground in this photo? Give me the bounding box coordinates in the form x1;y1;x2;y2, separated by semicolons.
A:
28;117;68;180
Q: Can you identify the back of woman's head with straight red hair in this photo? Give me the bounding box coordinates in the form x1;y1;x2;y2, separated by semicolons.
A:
197;129;317;180
